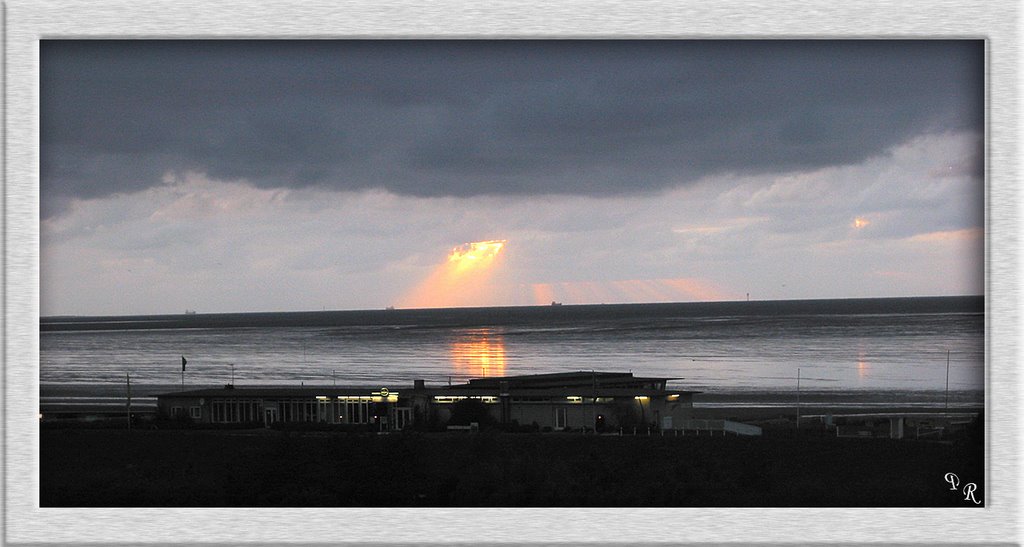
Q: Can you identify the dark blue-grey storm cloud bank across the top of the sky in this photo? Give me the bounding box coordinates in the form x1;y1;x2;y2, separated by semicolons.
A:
40;41;984;214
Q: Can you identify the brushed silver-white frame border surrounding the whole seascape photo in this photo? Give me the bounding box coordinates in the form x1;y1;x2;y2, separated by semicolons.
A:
3;0;1024;545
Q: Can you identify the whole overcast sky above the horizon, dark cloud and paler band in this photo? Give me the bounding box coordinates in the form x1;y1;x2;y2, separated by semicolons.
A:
40;41;984;315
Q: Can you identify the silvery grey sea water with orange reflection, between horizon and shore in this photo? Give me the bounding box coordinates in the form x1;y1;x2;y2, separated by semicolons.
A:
39;296;985;401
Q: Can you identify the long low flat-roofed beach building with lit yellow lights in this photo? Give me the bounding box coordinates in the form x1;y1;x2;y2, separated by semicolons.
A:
157;372;696;432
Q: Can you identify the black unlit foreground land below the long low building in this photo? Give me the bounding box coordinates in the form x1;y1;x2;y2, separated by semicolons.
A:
40;428;985;507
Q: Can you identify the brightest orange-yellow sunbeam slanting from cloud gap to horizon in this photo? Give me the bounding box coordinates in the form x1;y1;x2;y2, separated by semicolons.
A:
401;240;507;307
